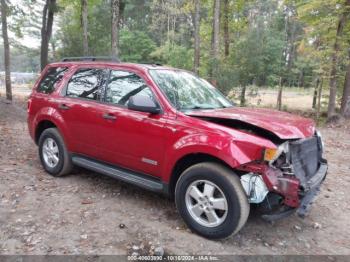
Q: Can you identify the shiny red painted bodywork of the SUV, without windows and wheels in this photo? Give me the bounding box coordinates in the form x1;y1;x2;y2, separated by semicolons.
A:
28;62;315;206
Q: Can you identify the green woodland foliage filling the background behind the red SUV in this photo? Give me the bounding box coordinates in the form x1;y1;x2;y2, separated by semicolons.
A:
2;0;350;116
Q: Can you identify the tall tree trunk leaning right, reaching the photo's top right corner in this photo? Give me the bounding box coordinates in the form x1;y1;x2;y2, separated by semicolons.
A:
327;0;350;118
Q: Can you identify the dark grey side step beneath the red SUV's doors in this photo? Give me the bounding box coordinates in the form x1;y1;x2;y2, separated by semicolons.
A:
72;155;166;193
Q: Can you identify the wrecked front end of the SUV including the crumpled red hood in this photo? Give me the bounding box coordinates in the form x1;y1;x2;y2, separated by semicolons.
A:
189;110;328;221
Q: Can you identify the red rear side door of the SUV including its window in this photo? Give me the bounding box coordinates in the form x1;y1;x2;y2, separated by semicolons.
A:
57;67;108;158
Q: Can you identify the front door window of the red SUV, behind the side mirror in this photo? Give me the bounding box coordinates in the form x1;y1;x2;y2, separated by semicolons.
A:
106;70;154;106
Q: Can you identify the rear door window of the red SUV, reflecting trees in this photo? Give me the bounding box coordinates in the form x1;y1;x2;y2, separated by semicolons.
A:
66;68;107;100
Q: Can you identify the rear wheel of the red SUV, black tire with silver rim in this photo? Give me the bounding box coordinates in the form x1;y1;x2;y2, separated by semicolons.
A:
39;128;73;176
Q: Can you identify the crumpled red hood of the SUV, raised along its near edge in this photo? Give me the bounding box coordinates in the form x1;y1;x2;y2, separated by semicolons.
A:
186;107;315;139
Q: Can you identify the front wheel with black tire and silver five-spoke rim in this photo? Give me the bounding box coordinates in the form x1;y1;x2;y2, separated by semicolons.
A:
175;162;250;239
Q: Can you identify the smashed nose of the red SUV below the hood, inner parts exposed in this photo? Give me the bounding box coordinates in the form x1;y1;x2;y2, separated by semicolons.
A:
238;132;328;221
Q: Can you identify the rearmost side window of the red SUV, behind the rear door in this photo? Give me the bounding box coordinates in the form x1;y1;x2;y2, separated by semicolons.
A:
37;67;68;94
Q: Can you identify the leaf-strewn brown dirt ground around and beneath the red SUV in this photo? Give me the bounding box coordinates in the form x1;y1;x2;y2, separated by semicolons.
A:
0;99;350;255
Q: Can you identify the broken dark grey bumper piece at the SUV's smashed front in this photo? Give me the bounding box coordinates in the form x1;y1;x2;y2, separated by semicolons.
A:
296;159;328;217
